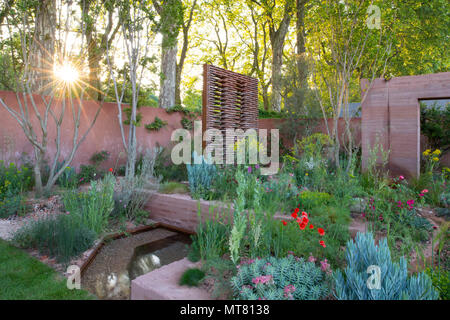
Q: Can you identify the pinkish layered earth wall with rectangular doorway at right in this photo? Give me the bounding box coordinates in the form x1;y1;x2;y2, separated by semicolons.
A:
361;72;450;176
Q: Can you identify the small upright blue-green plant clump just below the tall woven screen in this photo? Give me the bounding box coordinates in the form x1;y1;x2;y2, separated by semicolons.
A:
186;151;217;198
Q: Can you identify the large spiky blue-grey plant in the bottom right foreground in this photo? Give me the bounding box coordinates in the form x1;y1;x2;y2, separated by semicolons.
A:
334;232;438;300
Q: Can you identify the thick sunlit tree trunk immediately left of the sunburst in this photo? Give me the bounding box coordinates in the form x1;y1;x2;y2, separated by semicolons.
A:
30;0;56;94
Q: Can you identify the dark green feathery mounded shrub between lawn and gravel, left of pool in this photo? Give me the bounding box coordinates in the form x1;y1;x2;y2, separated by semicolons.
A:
14;214;96;262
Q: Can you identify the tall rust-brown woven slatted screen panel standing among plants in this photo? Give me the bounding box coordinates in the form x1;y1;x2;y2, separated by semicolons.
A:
202;64;258;159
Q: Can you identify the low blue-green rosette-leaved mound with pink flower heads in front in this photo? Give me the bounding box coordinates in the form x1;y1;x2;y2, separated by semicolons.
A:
231;255;329;300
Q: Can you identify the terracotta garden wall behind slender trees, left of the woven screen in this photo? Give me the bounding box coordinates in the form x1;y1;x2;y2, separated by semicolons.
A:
0;91;182;167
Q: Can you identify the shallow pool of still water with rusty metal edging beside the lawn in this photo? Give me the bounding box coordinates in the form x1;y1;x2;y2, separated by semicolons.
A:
81;227;190;300
